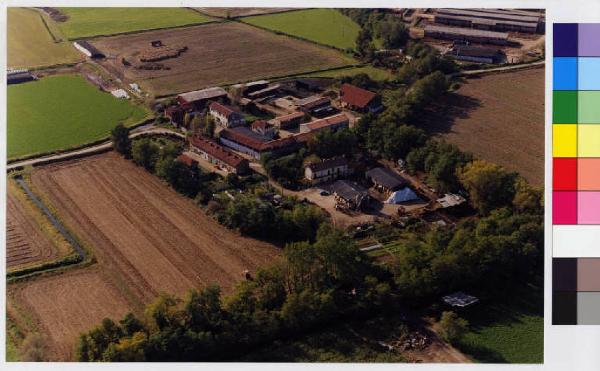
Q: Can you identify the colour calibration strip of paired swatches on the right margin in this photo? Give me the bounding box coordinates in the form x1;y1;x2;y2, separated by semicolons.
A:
552;23;600;325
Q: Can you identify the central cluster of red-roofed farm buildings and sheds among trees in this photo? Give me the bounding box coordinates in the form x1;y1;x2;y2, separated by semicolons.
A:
164;79;464;218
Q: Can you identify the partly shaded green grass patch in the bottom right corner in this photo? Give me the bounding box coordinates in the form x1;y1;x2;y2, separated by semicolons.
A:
459;287;544;363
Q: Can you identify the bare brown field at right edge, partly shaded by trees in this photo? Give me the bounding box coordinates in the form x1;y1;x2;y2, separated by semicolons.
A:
424;67;544;186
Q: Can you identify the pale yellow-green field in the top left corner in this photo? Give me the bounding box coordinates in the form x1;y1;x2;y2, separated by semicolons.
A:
7;8;82;68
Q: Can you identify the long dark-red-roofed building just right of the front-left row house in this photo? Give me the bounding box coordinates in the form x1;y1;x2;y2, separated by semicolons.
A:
219;127;299;159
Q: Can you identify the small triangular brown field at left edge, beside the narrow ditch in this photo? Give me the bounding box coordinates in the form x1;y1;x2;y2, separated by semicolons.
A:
6;191;59;270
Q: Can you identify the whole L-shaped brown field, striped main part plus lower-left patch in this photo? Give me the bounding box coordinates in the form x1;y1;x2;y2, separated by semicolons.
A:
9;153;279;360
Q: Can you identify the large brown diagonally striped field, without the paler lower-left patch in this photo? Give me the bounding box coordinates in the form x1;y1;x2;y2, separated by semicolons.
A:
32;153;278;302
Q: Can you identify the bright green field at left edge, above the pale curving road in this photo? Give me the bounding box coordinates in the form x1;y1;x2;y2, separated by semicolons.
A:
7;75;148;159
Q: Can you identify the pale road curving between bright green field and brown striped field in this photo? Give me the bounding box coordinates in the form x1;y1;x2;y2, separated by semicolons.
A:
6;125;185;170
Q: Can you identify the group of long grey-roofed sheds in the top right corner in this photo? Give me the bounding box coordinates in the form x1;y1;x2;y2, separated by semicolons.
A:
395;8;545;63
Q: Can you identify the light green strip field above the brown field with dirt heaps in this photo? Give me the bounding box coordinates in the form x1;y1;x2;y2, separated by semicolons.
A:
57;8;211;40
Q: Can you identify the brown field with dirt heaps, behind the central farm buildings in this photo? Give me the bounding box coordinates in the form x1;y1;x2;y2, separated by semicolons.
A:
93;22;350;96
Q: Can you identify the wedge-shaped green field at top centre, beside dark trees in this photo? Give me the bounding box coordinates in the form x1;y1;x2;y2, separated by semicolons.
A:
242;9;360;49
